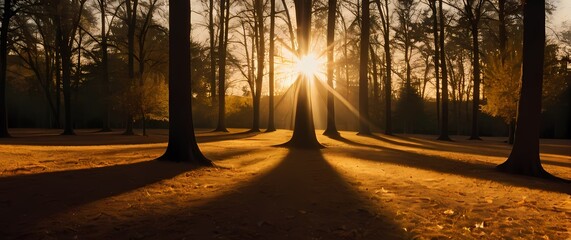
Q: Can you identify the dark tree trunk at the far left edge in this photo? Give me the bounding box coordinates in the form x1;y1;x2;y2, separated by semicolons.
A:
0;0;12;138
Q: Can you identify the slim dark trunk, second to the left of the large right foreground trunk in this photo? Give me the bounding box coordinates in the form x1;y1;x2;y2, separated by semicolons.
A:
438;0;451;141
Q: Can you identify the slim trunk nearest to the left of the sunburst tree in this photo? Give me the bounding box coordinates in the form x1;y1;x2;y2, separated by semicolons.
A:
266;0;276;132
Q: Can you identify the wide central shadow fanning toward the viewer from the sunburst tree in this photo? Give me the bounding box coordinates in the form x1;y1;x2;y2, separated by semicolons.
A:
72;150;406;239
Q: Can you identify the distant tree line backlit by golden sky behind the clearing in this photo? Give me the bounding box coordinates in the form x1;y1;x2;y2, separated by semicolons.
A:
0;0;571;142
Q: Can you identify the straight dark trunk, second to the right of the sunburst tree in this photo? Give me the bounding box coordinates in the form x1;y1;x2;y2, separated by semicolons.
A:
358;0;371;135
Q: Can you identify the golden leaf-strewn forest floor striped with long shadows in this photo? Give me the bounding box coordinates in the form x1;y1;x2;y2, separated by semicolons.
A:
0;129;571;240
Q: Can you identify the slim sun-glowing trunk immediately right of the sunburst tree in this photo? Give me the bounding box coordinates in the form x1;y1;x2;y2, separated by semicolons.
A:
323;0;339;137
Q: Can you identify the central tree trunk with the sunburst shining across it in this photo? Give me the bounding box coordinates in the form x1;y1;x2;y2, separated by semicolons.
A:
284;0;323;149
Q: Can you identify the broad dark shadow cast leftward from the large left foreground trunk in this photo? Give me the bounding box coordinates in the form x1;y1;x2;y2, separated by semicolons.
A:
0;161;199;239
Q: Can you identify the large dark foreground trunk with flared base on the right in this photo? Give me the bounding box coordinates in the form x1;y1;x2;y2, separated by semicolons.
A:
497;0;552;178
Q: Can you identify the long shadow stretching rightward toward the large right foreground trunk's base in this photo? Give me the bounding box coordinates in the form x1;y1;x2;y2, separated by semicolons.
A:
326;137;571;194
